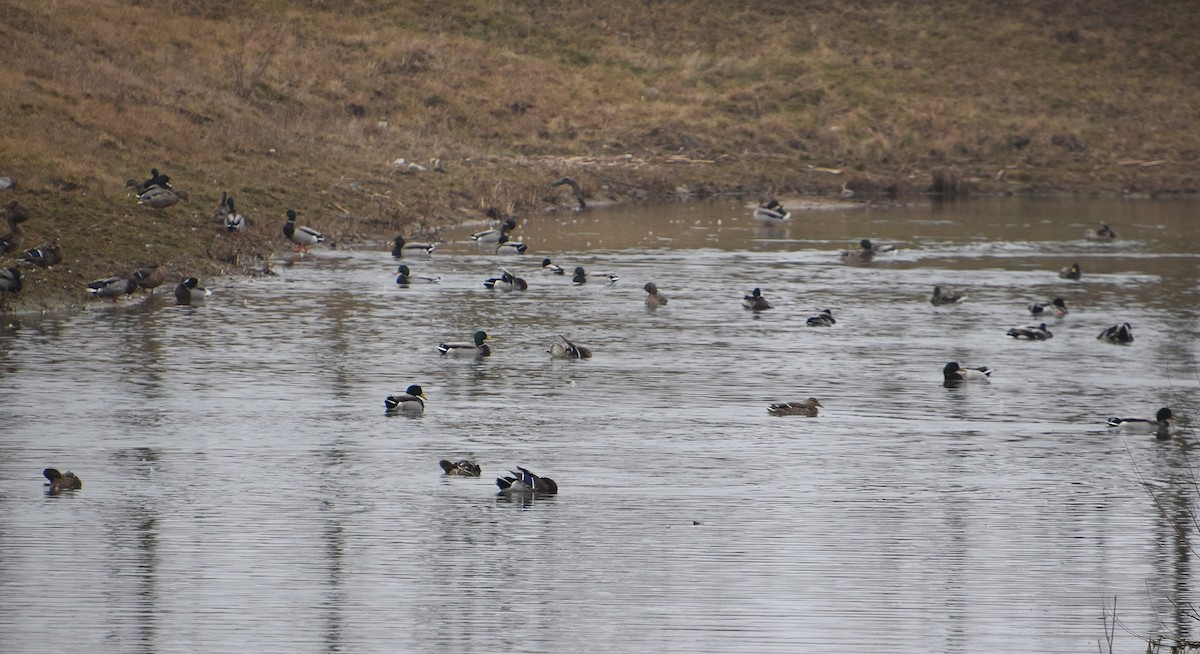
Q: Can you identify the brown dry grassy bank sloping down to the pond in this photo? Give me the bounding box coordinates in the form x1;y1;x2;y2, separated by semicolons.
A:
0;0;1200;308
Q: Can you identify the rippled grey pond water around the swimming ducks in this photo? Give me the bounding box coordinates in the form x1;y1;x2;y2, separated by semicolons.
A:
0;199;1200;653
